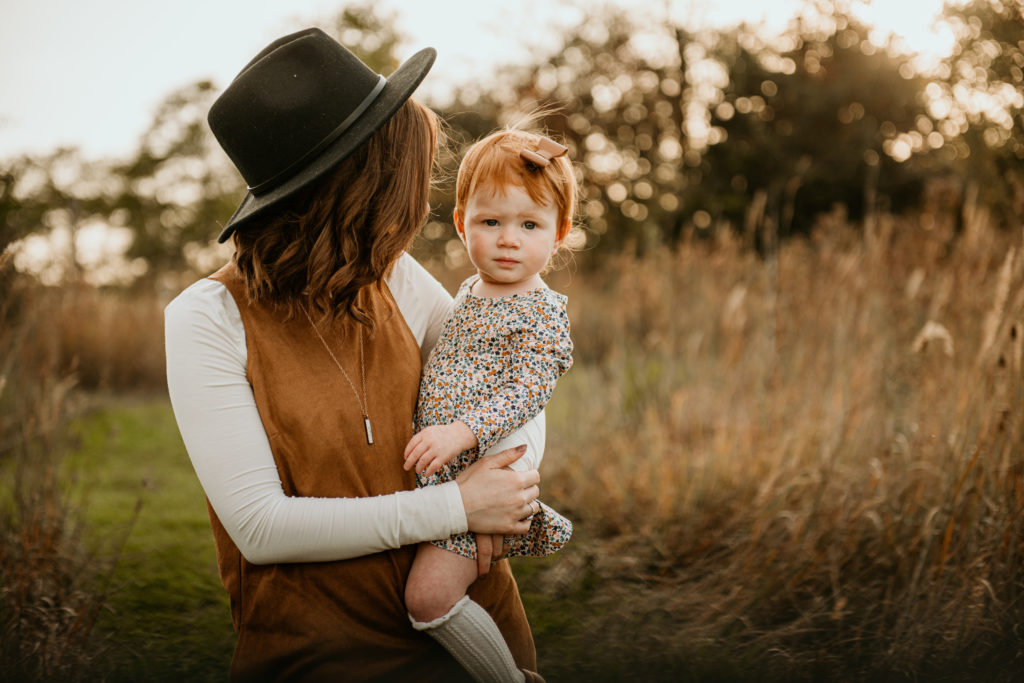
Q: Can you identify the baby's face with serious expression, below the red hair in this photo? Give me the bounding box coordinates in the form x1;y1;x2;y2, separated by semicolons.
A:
456;185;560;288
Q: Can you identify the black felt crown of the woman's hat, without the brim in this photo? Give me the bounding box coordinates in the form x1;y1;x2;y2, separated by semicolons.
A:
208;29;381;194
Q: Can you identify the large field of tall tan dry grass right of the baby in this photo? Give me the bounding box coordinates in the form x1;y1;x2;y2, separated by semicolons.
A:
531;205;1024;680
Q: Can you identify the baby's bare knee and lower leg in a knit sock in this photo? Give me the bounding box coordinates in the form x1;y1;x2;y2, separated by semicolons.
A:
406;543;524;683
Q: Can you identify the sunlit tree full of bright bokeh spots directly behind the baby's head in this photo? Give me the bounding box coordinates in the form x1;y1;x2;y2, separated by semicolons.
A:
436;9;689;255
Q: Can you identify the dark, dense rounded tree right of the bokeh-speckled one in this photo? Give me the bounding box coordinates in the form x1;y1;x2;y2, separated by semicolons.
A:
700;3;941;239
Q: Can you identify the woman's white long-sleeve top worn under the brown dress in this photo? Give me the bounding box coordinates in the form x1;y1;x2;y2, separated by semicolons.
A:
164;254;544;564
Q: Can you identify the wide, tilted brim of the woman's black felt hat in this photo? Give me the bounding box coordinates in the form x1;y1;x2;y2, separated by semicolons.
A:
217;47;437;243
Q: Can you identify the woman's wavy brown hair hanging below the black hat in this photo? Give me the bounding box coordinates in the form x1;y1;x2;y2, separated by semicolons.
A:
234;99;438;330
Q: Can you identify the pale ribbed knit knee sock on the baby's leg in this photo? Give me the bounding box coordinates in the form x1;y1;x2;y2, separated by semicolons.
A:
409;595;525;683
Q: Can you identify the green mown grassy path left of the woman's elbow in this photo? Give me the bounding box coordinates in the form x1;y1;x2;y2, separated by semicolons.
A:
69;399;234;681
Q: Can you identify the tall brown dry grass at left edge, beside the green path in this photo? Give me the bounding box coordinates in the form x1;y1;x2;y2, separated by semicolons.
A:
0;257;145;681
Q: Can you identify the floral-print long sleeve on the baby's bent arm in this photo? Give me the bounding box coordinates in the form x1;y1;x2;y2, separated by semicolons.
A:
459;300;572;453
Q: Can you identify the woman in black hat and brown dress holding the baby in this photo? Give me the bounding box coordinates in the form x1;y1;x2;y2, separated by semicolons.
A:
166;29;543;681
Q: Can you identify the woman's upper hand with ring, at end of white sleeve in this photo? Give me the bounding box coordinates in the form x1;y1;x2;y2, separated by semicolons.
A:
456;445;541;535
